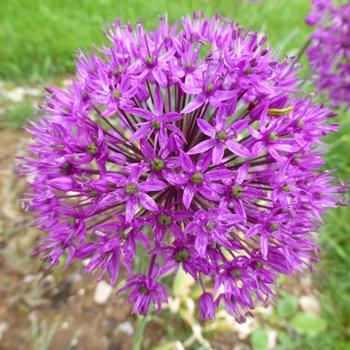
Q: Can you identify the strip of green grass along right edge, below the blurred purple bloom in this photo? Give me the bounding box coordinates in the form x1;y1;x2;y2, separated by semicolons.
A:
317;111;350;350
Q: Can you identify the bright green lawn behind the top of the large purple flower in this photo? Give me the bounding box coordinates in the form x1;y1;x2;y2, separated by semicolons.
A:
0;0;309;81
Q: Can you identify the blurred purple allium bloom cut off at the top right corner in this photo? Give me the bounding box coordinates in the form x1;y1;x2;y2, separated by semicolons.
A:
306;0;350;108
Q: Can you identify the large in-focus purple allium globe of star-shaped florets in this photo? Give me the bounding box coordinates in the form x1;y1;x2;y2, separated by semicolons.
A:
22;13;341;322
